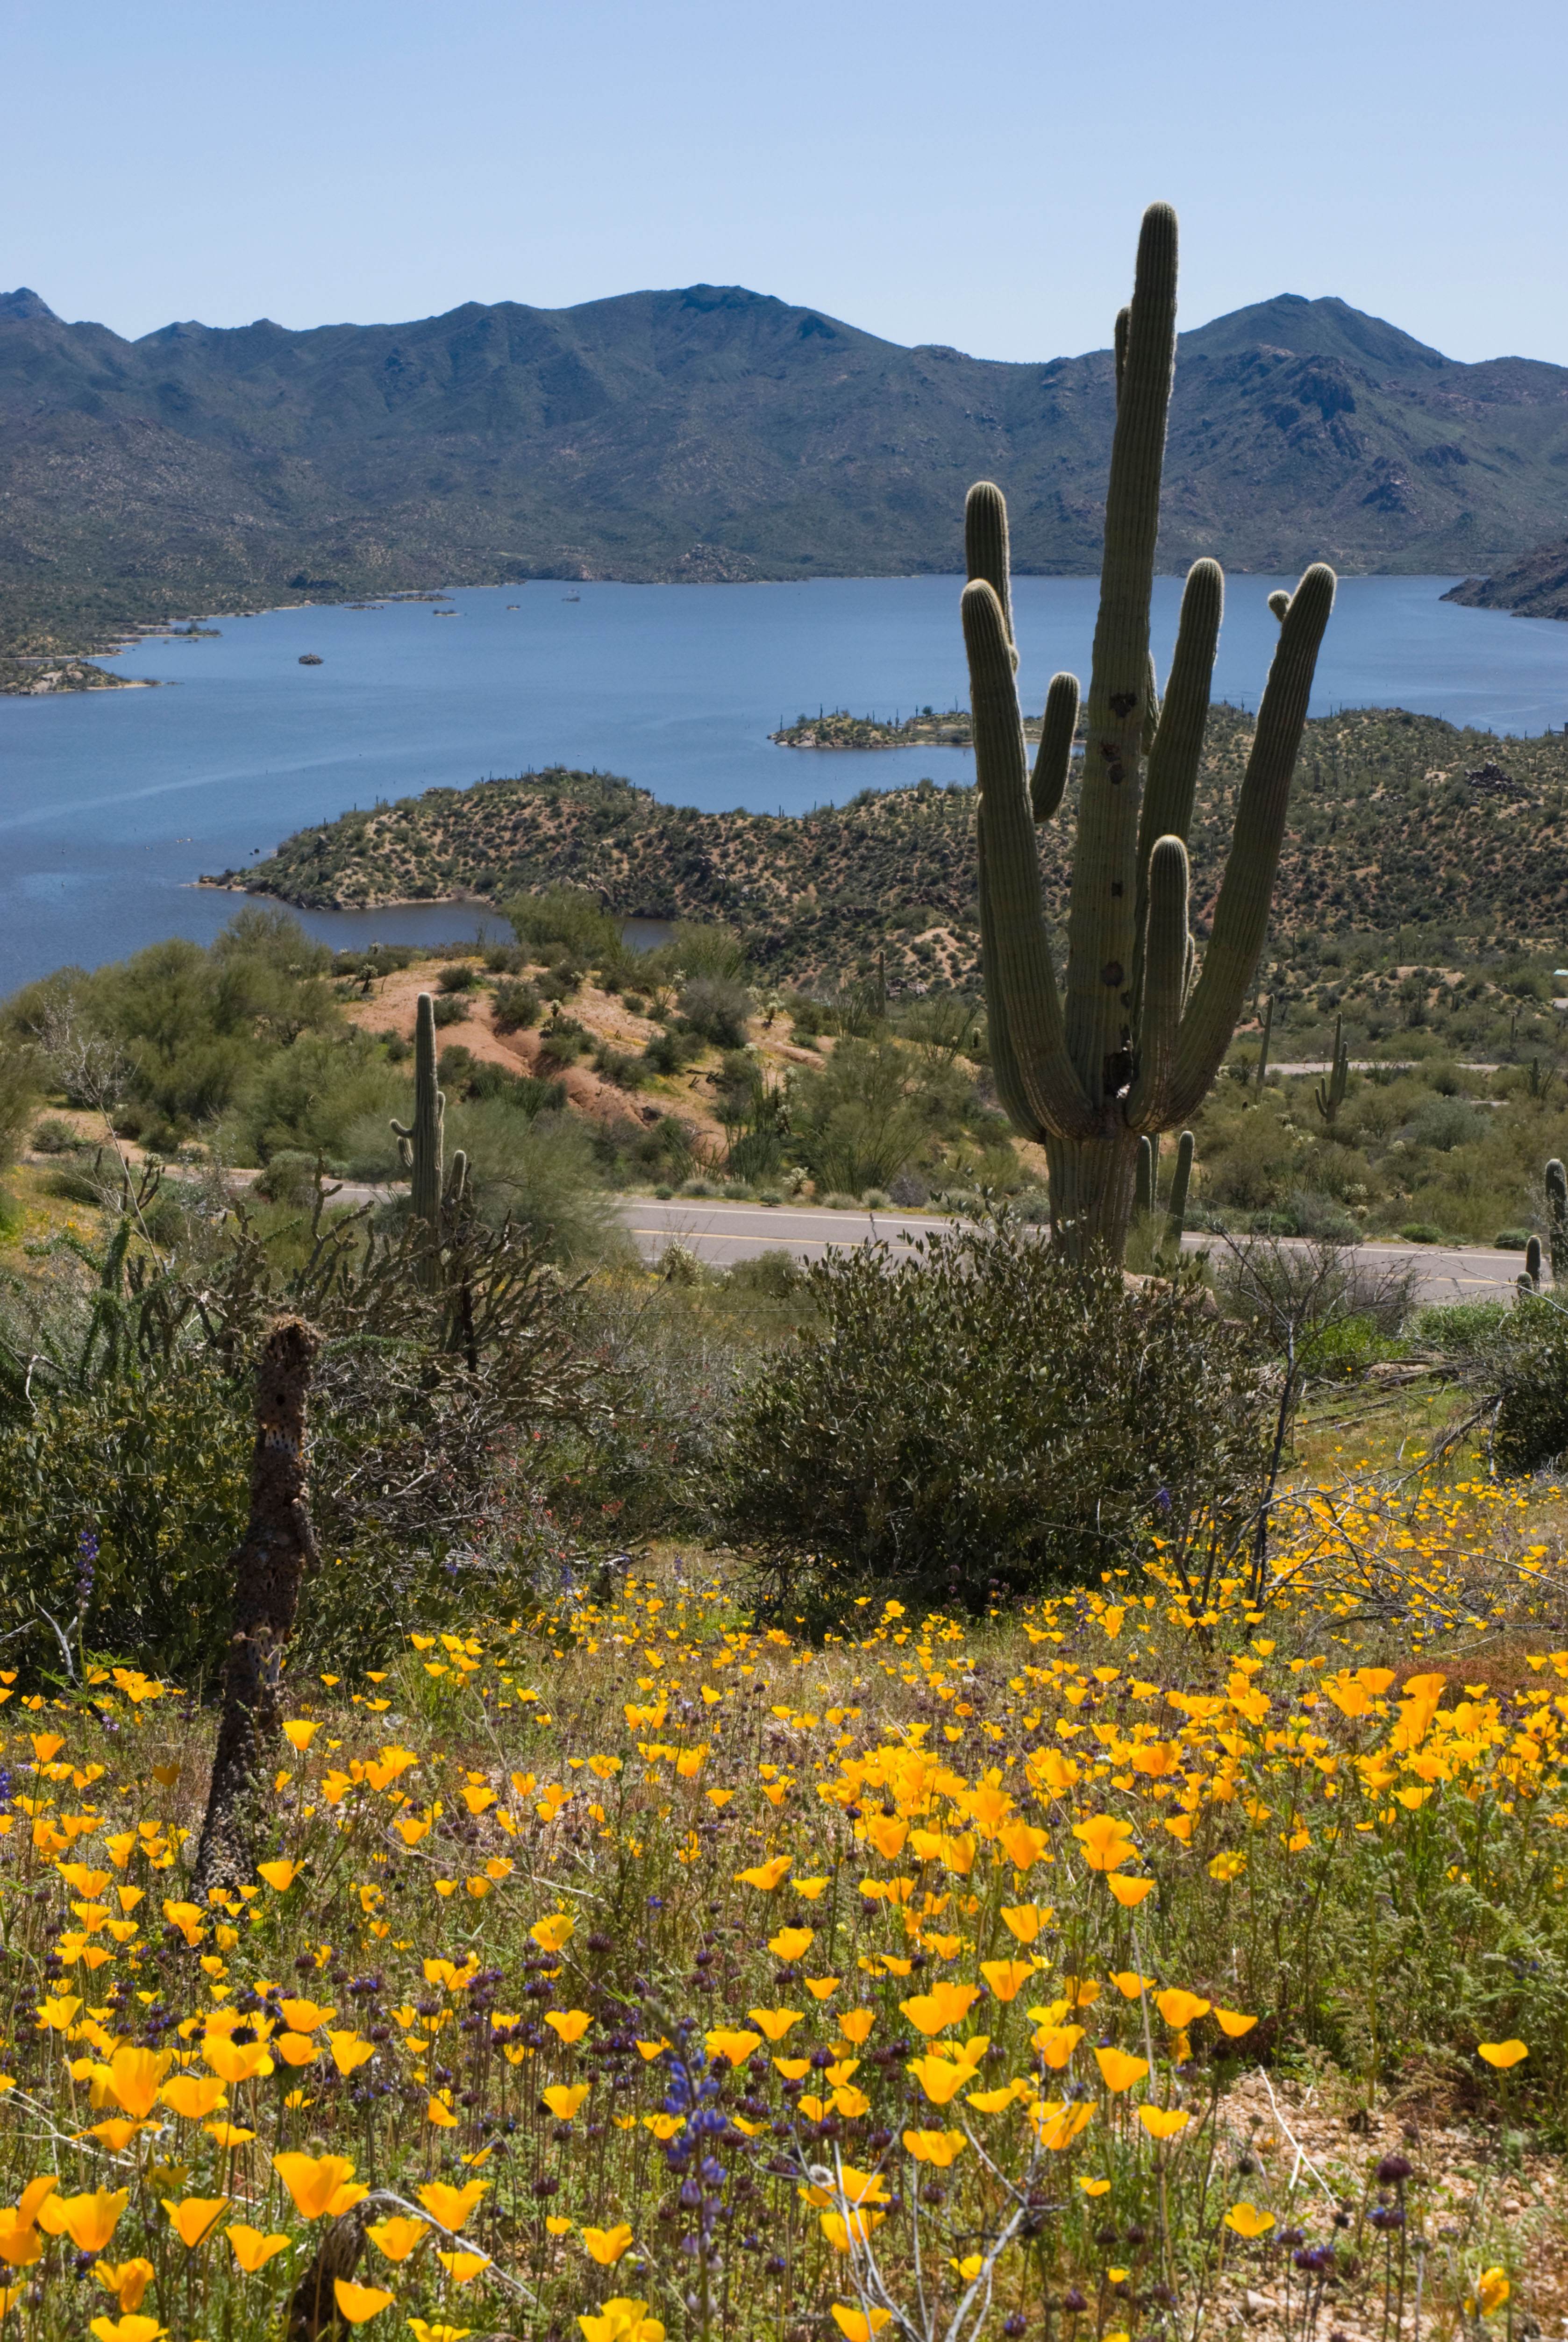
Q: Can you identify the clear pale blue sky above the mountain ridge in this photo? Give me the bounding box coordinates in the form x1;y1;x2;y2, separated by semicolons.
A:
0;0;1568;363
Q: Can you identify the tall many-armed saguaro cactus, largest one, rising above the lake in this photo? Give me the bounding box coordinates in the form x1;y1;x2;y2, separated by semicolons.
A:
963;204;1333;1258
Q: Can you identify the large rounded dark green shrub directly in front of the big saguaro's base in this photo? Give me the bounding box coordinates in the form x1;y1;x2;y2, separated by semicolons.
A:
720;1220;1268;1609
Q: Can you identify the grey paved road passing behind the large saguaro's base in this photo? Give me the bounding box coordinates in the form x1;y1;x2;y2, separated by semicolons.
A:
619;1195;1524;1302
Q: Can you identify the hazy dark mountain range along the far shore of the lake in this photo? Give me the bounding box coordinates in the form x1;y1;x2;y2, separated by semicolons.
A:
0;286;1568;647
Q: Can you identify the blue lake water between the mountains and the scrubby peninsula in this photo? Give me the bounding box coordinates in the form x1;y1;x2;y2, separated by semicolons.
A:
0;576;1568;990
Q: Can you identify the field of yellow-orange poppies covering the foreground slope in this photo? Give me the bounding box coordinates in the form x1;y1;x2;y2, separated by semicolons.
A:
0;1473;1568;2342
